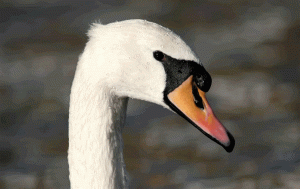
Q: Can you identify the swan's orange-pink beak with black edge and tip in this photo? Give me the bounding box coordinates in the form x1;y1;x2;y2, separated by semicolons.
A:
167;76;235;152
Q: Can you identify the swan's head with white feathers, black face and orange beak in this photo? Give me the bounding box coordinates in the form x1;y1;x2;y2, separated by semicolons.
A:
82;20;235;152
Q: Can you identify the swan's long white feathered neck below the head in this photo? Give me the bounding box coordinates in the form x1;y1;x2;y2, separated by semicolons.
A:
68;73;128;189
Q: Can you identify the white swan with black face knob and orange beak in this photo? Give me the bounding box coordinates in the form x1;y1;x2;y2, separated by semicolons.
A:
68;20;235;189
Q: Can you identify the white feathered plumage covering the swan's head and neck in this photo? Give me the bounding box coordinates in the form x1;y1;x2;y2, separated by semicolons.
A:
68;20;198;189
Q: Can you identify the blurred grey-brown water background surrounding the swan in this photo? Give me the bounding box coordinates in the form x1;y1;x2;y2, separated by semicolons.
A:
0;0;300;189
